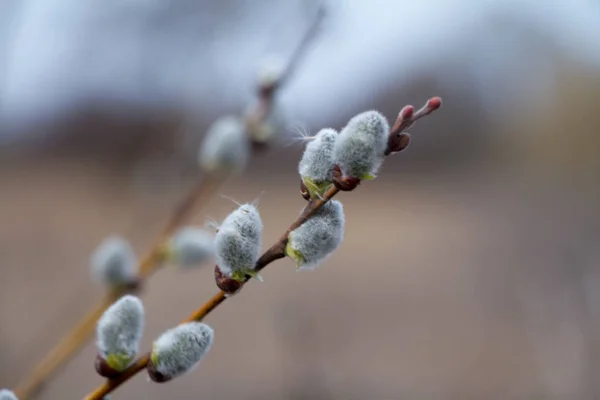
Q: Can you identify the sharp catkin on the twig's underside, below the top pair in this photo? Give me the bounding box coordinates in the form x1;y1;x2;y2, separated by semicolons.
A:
285;200;345;270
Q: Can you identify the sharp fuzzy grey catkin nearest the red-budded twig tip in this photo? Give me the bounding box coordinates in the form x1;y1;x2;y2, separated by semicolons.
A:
333;111;390;179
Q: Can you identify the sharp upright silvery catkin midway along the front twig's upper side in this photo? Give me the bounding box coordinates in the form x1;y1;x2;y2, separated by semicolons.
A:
215;204;263;276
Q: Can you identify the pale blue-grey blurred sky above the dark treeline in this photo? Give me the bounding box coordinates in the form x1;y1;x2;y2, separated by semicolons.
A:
0;0;600;139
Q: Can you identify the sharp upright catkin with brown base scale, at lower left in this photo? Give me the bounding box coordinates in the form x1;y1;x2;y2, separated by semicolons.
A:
96;295;144;377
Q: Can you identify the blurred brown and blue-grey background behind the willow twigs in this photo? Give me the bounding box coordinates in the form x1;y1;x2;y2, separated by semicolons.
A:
0;0;600;400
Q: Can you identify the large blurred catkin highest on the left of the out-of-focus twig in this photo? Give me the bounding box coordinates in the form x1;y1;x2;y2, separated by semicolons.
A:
198;116;250;174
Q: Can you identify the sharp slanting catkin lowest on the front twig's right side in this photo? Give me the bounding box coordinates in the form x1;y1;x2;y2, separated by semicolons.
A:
148;322;214;382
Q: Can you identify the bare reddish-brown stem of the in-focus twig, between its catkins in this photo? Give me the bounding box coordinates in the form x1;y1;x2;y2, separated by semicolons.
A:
84;97;441;400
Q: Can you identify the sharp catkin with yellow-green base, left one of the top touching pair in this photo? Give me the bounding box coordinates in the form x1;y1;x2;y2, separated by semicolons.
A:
298;128;339;198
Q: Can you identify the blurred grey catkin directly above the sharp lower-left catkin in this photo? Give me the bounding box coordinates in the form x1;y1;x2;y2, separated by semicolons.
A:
90;236;138;286
